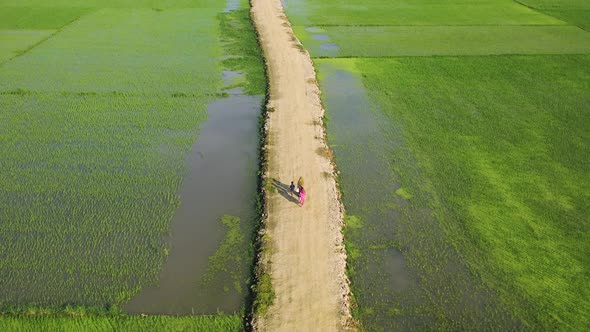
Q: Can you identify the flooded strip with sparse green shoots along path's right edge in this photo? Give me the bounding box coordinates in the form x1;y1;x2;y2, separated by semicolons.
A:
318;61;514;330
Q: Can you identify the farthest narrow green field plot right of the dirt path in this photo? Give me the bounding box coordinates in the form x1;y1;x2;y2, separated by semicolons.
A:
286;0;565;26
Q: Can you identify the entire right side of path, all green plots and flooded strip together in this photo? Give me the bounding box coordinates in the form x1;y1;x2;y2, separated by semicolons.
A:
286;0;590;331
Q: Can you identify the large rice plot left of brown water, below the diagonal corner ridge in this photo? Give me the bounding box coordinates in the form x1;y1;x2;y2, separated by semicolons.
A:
0;4;229;307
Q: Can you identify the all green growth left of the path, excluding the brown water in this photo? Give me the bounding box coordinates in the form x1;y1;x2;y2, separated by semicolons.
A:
0;0;265;331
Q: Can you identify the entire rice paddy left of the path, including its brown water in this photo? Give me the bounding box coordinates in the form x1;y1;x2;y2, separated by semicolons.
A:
0;0;265;324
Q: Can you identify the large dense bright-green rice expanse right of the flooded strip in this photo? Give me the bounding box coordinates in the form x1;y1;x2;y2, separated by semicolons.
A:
356;55;590;330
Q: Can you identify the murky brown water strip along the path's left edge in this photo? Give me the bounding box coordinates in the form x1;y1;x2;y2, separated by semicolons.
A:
125;85;263;315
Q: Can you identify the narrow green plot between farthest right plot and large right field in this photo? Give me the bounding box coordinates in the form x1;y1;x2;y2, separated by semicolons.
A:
294;26;590;57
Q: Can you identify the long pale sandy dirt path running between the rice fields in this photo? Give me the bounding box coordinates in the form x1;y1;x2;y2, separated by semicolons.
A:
252;0;350;332
